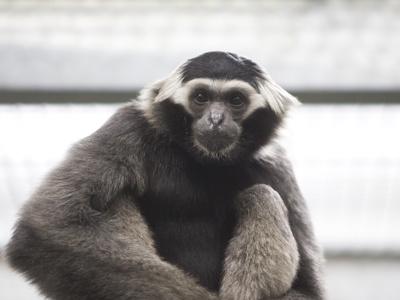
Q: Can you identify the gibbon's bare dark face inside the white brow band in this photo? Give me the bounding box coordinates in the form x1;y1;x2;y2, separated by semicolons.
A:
188;87;249;155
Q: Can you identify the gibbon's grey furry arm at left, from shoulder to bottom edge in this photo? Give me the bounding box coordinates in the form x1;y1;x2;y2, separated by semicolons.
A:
6;105;216;300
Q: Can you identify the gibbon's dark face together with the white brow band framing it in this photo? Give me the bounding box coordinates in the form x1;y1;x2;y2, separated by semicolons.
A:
176;78;266;156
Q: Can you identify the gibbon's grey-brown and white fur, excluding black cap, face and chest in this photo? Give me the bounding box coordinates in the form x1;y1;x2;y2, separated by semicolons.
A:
6;54;324;300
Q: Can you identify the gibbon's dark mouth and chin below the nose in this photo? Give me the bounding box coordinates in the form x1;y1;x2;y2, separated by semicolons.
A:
194;128;237;153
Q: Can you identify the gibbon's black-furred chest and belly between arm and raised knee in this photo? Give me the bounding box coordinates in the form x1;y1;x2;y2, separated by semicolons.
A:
139;155;250;290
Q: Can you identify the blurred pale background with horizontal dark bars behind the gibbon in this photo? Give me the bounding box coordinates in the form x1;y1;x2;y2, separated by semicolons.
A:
0;0;400;300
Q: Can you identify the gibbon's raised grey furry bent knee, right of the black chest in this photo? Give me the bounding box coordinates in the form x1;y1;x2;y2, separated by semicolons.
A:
220;184;299;300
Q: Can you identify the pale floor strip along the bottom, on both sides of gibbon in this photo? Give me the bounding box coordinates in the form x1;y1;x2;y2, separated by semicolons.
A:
0;258;400;300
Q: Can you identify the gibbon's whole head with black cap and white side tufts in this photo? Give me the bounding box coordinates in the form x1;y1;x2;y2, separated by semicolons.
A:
139;52;298;163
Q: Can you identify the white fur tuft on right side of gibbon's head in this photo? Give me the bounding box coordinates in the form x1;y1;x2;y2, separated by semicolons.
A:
259;72;300;117
